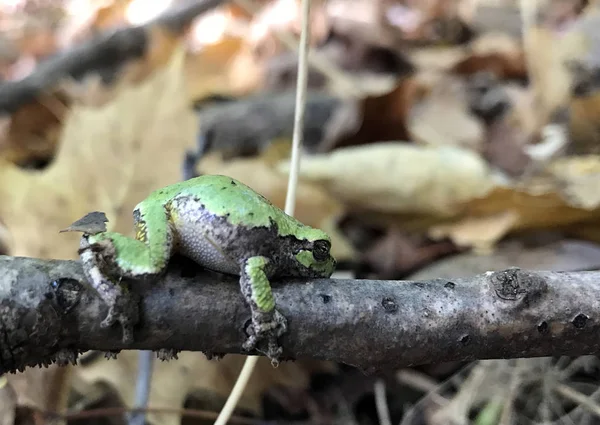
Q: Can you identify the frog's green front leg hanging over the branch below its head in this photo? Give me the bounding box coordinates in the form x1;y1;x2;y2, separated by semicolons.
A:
240;256;287;362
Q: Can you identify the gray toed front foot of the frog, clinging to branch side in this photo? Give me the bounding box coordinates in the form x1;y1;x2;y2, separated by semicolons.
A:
242;310;287;365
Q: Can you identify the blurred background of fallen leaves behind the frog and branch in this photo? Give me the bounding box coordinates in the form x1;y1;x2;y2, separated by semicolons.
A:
0;0;600;425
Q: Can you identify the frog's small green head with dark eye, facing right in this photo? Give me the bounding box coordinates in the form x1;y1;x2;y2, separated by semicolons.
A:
294;227;336;277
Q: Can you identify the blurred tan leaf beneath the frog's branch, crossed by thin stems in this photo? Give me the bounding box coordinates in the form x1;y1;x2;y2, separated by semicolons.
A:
77;351;333;425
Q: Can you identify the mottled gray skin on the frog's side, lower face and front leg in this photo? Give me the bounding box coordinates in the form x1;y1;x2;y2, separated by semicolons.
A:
168;197;332;360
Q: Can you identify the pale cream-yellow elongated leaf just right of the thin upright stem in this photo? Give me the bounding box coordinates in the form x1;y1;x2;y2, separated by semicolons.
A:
278;142;494;216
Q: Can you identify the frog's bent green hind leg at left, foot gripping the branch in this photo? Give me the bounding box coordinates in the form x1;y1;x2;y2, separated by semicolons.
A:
79;204;173;343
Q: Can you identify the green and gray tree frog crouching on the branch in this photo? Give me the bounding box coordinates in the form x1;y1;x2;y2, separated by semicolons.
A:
71;175;336;360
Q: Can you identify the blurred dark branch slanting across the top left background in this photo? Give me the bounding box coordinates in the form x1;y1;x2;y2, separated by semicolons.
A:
0;0;223;113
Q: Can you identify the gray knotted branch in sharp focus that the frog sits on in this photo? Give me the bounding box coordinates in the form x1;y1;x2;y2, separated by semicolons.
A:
0;256;600;373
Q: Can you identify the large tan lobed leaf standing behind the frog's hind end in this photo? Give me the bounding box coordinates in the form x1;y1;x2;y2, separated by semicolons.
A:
0;45;197;258
